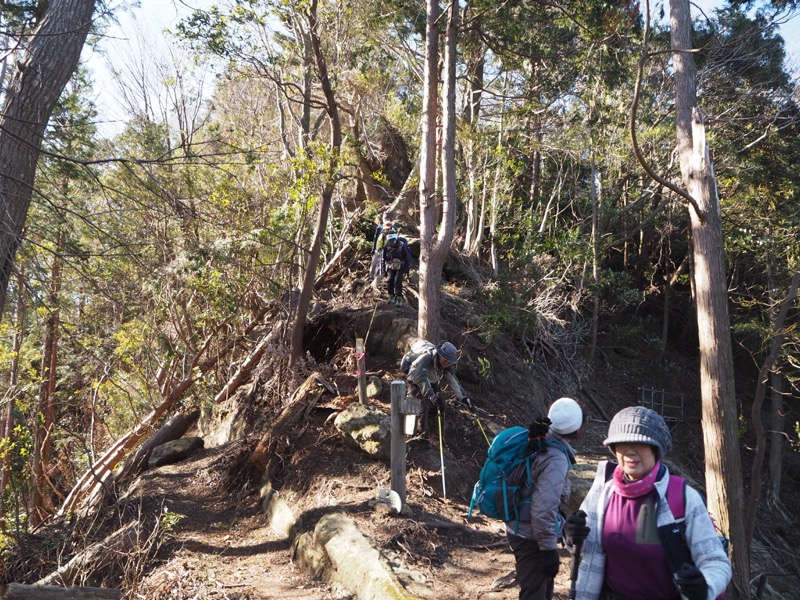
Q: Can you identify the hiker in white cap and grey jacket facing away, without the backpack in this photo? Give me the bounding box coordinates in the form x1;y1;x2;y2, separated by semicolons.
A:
505;398;583;600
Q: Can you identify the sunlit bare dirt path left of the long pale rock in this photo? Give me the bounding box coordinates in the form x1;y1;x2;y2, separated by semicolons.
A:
133;444;347;600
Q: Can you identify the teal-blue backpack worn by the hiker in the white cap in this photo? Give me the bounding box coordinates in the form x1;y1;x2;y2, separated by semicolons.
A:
468;426;572;521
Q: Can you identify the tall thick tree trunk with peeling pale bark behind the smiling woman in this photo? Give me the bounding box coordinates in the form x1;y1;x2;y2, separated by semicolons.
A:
670;0;750;598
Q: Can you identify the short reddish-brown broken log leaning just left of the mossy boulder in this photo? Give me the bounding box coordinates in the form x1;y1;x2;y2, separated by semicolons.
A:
250;373;330;477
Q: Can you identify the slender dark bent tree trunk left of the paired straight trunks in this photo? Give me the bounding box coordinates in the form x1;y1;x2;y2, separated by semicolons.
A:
291;0;342;363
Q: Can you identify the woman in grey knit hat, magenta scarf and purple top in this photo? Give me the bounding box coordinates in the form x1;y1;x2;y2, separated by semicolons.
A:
565;406;731;600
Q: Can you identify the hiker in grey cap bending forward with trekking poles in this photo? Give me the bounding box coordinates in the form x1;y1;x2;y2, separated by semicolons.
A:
400;340;475;436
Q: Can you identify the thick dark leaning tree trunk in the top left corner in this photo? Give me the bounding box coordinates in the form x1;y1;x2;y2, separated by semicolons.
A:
0;0;95;314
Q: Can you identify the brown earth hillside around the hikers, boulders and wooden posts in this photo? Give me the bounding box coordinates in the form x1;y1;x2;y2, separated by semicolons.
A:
11;246;800;600
